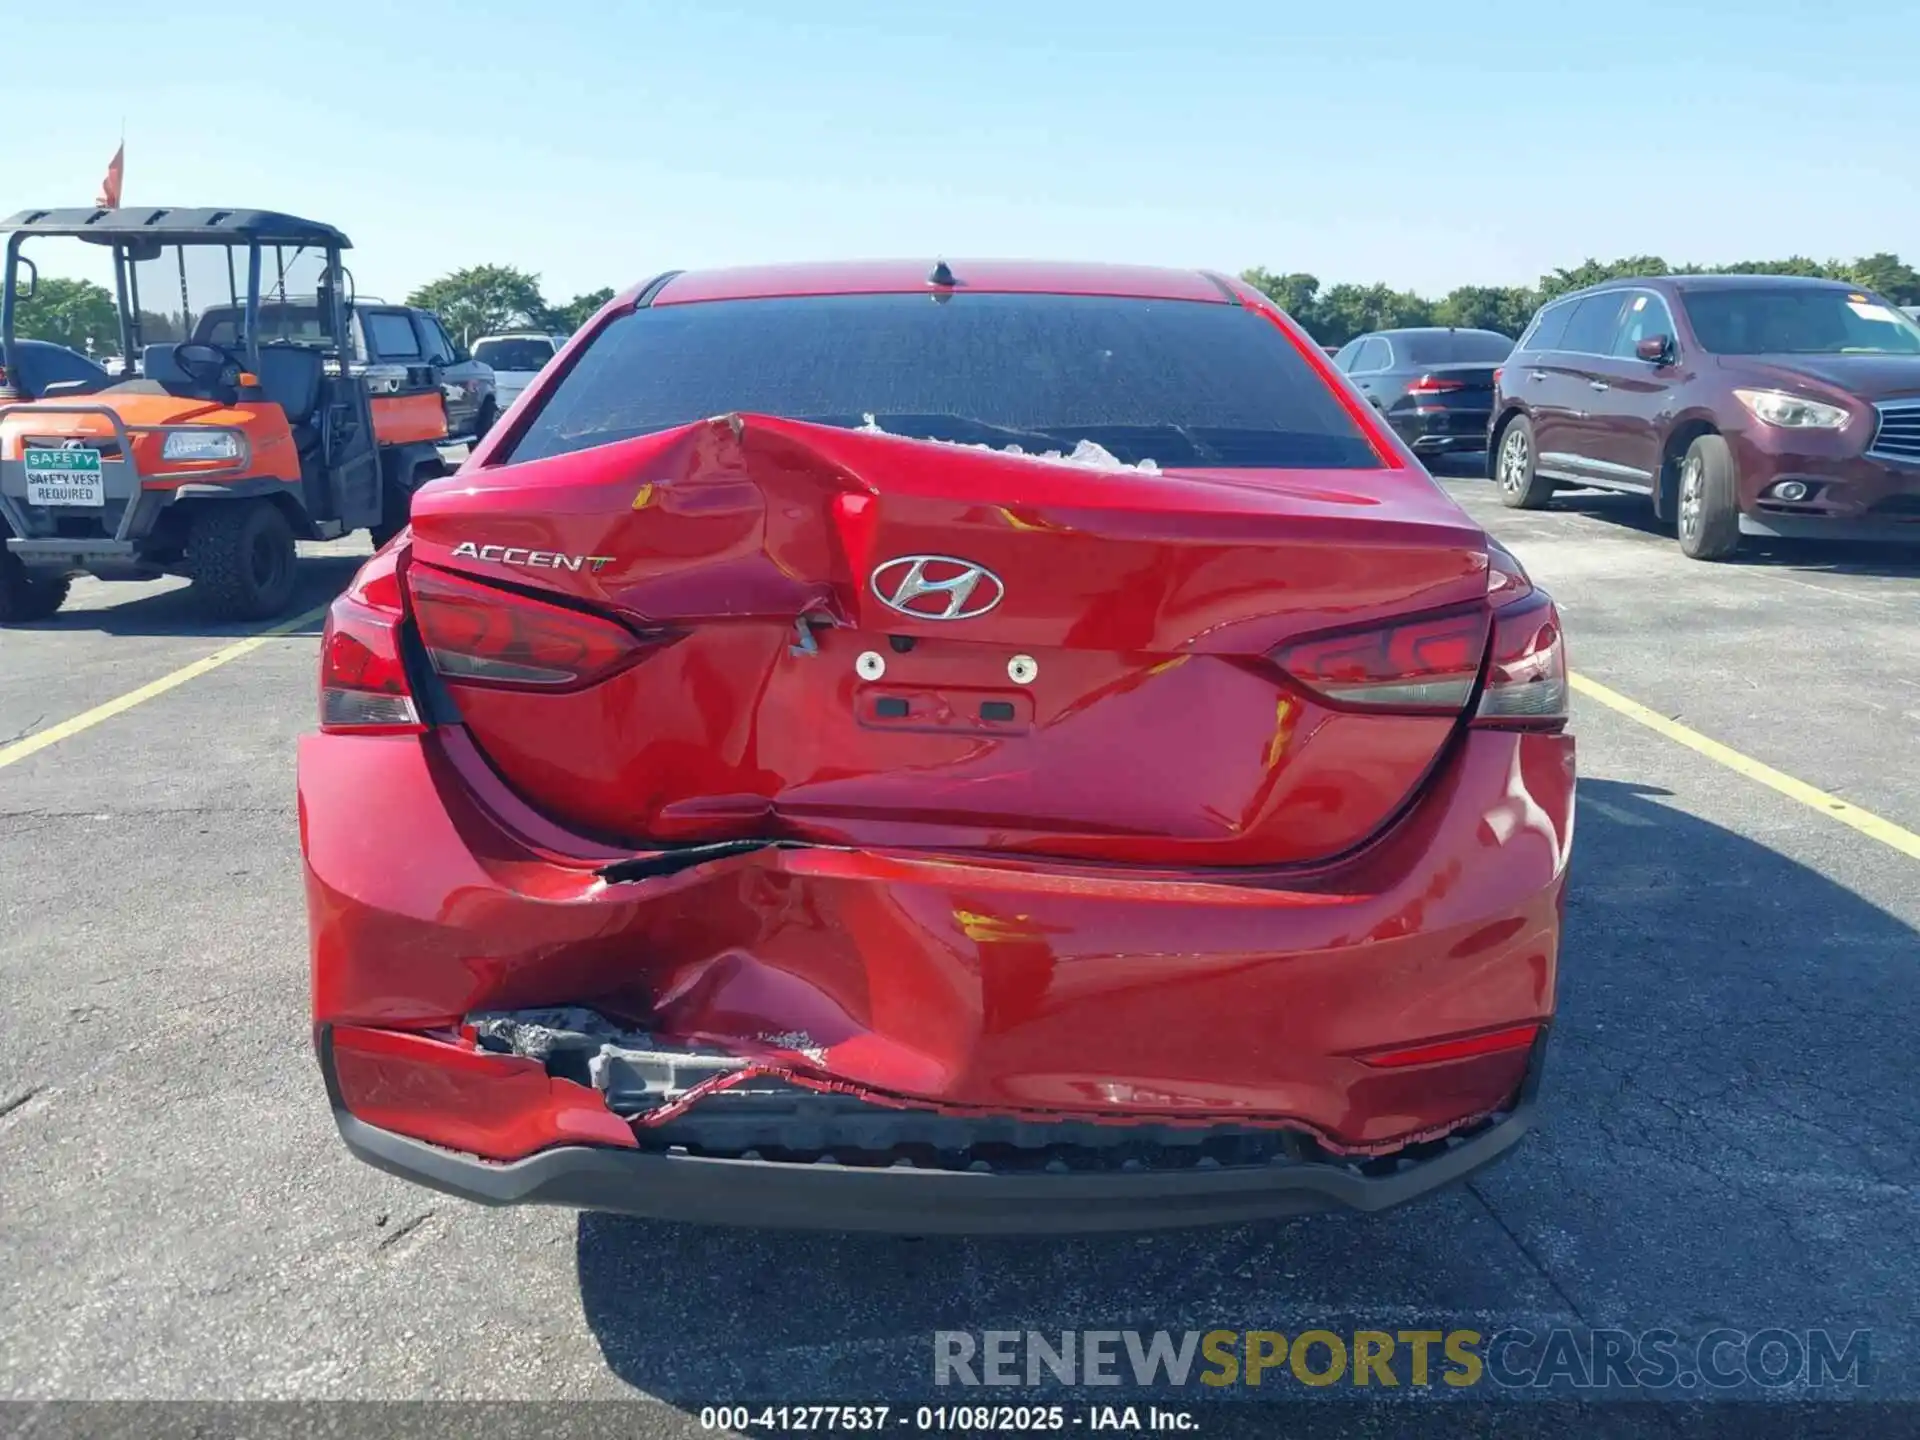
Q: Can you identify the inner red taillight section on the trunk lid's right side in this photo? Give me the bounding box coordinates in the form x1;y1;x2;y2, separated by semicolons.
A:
1273;607;1490;714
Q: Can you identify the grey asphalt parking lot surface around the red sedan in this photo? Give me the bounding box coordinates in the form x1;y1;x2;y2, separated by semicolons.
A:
0;478;1920;1436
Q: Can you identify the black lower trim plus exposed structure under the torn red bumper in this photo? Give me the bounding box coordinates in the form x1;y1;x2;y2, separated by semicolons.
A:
321;1008;1546;1235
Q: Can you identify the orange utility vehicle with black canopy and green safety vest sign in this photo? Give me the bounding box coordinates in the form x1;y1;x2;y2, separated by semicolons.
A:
0;209;447;622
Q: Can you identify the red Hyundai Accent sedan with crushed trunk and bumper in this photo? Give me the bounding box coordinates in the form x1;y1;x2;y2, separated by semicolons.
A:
300;261;1574;1233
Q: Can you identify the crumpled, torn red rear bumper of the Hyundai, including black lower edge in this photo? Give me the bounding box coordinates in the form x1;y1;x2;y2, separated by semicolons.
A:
300;732;1572;1229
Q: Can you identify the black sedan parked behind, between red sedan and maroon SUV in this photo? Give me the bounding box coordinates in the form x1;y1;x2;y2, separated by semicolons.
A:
1332;326;1513;459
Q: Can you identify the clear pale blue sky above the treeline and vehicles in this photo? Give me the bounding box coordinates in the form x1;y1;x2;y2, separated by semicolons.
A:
0;0;1920;300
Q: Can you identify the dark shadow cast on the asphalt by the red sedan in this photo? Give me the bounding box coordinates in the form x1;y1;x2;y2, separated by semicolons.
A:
576;780;1920;1407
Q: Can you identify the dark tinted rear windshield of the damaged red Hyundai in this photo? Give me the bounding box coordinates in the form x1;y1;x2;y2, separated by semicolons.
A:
515;294;1380;468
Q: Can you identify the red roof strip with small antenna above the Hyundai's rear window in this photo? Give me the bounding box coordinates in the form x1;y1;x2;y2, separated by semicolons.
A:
653;259;1238;305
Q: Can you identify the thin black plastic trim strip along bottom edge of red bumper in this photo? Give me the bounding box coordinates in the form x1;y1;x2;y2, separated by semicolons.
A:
334;1098;1532;1235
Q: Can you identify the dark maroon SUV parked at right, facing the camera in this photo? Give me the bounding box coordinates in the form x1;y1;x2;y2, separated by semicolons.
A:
1488;275;1920;561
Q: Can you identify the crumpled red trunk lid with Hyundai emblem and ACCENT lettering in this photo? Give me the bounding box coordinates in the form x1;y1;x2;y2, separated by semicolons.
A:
411;417;1486;866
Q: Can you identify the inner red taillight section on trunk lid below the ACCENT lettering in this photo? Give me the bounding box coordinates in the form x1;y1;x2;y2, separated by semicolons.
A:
407;564;655;691
